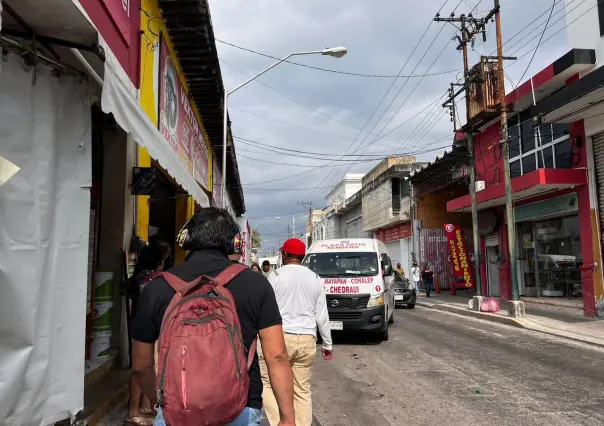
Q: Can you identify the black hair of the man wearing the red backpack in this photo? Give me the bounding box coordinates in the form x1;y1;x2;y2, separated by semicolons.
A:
187;207;239;255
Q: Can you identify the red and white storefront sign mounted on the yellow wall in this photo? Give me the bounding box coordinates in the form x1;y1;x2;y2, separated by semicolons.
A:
159;37;208;188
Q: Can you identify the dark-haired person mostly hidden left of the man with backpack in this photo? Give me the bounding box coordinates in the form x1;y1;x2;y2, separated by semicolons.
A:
124;243;170;426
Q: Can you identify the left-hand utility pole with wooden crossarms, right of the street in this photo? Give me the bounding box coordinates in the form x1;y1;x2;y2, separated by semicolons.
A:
434;9;490;300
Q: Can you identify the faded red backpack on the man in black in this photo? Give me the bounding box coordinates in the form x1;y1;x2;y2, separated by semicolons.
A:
157;264;256;426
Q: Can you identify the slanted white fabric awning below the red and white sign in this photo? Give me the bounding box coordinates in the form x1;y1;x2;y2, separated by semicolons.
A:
101;61;210;207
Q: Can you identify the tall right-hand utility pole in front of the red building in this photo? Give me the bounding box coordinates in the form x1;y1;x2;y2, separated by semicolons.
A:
494;0;524;317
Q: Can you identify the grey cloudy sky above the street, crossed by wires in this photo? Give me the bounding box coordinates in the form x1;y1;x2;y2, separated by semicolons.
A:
210;0;581;253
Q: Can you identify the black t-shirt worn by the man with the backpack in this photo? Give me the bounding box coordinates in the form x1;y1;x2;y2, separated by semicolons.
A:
132;251;282;409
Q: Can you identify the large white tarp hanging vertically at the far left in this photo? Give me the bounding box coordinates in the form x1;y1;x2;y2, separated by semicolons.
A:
0;54;92;425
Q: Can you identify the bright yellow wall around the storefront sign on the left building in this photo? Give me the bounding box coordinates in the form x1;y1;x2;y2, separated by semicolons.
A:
136;0;214;253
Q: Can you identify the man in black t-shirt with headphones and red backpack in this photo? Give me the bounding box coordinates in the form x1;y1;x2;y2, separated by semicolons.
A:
132;208;295;426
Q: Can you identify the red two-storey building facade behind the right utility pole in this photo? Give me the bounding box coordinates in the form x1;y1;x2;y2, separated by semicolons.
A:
447;49;600;317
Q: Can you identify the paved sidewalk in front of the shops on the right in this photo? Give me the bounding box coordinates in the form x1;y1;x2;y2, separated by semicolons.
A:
417;293;604;348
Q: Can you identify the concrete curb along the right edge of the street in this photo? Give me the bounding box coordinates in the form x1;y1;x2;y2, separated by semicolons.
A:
416;300;604;348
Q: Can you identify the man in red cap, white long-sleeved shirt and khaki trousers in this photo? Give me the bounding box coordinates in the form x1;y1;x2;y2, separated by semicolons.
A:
259;238;333;426
